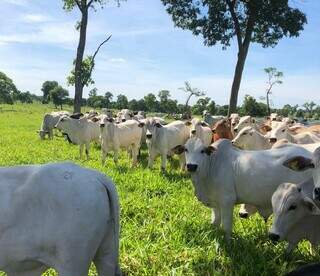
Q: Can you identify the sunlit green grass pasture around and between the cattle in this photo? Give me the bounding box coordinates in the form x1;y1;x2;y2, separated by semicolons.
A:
0;104;319;276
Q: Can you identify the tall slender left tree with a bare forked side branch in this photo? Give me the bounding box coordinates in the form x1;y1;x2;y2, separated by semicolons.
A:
63;0;120;112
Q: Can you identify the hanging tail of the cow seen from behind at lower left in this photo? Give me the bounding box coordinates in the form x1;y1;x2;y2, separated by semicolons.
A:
100;175;121;275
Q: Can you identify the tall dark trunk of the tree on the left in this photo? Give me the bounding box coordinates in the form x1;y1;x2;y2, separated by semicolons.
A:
73;7;88;113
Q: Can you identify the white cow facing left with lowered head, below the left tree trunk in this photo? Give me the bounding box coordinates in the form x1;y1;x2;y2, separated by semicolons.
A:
56;116;100;159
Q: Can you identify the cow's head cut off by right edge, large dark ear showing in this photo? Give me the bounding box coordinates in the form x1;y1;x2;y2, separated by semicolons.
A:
283;147;320;201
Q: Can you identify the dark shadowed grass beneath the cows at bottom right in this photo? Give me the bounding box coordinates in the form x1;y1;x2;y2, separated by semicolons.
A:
181;219;319;275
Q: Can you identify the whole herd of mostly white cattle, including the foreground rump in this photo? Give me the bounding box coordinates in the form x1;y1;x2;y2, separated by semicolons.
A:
0;109;320;276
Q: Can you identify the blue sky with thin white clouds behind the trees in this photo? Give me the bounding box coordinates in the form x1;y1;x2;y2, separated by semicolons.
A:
0;0;320;106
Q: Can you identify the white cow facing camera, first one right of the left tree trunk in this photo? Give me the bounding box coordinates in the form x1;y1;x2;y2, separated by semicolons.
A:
100;118;144;166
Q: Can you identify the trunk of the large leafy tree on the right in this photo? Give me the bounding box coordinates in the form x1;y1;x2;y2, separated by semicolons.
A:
228;43;249;116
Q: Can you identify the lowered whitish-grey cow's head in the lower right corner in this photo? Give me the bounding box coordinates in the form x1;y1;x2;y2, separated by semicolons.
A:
269;183;320;242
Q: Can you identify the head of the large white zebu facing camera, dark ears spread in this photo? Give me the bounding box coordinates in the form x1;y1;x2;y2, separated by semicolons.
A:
173;138;216;173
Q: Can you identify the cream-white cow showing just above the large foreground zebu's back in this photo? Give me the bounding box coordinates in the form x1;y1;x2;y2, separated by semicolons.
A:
232;126;272;150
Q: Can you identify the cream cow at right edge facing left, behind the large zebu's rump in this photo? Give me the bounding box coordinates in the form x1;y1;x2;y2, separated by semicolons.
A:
269;122;320;144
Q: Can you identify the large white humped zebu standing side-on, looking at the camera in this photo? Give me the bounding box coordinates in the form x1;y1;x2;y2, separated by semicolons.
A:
175;139;311;238
